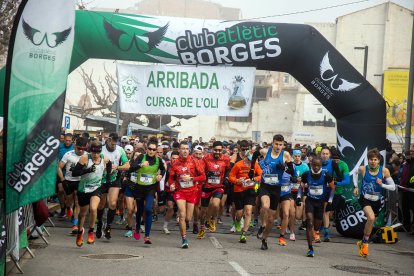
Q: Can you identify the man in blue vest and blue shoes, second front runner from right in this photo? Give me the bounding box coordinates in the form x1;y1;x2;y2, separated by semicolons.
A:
296;157;334;257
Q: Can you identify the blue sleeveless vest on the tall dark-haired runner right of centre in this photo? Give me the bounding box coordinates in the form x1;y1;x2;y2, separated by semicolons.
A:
259;147;285;186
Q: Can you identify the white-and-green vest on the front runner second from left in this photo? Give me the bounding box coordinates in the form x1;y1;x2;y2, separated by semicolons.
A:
78;154;105;193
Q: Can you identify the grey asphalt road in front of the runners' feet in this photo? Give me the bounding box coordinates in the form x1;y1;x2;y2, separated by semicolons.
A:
9;218;414;276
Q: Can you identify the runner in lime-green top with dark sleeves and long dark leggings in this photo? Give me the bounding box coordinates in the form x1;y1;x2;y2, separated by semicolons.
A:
125;139;165;244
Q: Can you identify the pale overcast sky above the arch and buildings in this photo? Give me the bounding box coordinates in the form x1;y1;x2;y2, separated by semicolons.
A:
89;0;414;23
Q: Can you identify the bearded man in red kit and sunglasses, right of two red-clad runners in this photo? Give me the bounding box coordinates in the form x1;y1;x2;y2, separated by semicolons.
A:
197;141;230;239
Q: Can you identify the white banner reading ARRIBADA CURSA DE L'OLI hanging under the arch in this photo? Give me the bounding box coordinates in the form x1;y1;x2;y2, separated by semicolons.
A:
117;63;256;117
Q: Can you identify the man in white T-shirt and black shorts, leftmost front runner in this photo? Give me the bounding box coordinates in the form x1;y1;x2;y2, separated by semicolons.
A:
58;137;88;235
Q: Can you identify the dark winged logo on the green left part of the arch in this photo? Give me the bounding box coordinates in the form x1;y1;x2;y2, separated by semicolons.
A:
104;19;169;53
